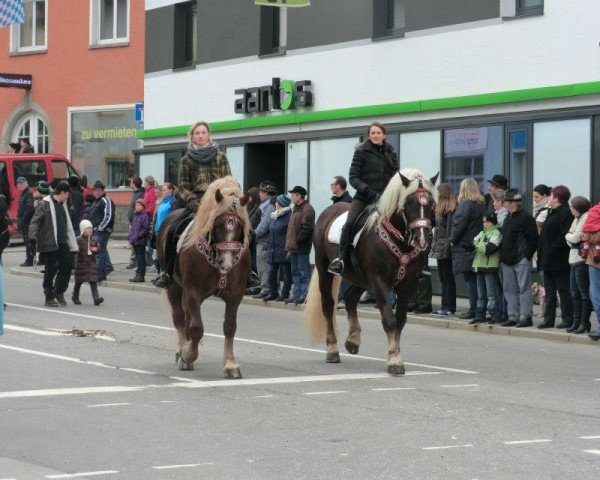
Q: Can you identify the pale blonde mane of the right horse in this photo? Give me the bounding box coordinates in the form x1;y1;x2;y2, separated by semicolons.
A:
366;168;437;230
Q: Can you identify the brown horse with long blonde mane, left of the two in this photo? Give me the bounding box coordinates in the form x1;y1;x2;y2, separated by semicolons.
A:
156;176;250;378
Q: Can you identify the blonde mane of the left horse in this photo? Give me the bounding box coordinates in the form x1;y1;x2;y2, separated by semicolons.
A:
182;175;250;248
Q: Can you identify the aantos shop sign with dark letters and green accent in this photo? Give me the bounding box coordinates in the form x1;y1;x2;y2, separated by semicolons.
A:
234;78;313;113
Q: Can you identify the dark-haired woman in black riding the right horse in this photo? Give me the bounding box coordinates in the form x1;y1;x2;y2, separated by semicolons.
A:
327;122;399;275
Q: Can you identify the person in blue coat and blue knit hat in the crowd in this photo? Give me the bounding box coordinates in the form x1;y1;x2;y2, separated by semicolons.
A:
263;195;292;302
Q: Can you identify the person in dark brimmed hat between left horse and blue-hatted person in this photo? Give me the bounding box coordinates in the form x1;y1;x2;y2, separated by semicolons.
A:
253;180;278;299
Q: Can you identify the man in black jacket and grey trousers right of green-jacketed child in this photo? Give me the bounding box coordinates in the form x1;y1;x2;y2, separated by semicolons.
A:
500;188;538;328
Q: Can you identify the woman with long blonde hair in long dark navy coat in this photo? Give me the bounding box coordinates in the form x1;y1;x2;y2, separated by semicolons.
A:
450;178;485;319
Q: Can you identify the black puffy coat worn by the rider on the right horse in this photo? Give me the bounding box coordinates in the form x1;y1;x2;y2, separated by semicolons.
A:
348;140;399;203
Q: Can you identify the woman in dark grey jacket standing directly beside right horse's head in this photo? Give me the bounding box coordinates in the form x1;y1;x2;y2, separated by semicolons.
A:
430;183;457;316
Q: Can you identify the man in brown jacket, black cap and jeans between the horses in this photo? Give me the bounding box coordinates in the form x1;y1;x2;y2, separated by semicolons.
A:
285;185;315;305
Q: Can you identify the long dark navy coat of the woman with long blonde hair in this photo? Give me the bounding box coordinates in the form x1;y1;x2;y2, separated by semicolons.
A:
450;200;485;274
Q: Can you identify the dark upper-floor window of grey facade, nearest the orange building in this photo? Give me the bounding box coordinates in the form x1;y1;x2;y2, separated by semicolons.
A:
173;1;198;68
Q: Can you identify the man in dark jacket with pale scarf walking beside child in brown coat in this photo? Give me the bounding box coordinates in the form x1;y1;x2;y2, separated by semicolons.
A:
29;181;78;307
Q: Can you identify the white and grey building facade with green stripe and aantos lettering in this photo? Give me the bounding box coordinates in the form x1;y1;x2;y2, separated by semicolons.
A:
142;0;600;220
